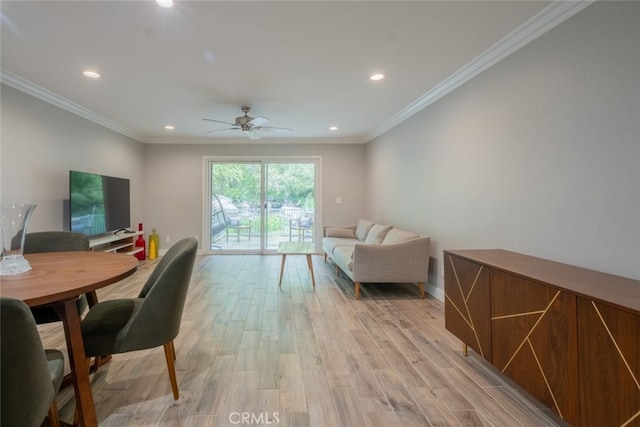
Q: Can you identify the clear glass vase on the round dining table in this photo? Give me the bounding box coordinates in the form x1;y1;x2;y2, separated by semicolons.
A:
0;203;36;276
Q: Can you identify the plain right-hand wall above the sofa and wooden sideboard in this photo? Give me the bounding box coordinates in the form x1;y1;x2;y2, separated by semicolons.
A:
367;2;640;297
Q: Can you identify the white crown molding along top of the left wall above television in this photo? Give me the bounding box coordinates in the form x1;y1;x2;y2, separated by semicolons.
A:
0;68;143;142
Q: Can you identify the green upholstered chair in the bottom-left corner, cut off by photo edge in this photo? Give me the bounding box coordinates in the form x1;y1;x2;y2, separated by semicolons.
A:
0;297;64;427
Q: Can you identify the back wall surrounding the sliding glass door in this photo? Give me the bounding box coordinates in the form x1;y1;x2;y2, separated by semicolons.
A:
144;139;366;249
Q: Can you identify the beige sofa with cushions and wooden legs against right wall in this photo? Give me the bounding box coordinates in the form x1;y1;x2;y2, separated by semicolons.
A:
322;219;431;299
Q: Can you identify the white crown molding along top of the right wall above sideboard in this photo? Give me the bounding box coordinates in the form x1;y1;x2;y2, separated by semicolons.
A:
366;0;595;142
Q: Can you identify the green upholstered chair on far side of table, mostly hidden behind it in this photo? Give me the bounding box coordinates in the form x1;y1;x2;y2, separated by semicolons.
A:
24;231;89;325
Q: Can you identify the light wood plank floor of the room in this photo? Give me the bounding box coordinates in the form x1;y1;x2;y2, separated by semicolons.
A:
40;255;561;427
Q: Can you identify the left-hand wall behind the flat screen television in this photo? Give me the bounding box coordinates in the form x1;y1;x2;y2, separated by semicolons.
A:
0;85;145;231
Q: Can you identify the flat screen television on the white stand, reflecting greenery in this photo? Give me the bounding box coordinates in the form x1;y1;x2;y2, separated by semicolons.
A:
69;171;131;236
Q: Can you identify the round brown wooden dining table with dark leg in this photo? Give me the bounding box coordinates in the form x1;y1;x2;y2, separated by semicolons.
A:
0;251;138;427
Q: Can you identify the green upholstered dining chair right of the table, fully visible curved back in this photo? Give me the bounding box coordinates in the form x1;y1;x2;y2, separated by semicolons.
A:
81;237;198;400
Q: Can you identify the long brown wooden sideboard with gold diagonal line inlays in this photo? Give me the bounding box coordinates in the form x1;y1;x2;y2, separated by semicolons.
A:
444;249;640;427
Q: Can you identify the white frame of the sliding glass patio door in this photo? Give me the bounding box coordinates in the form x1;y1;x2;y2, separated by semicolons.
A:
202;155;323;255
